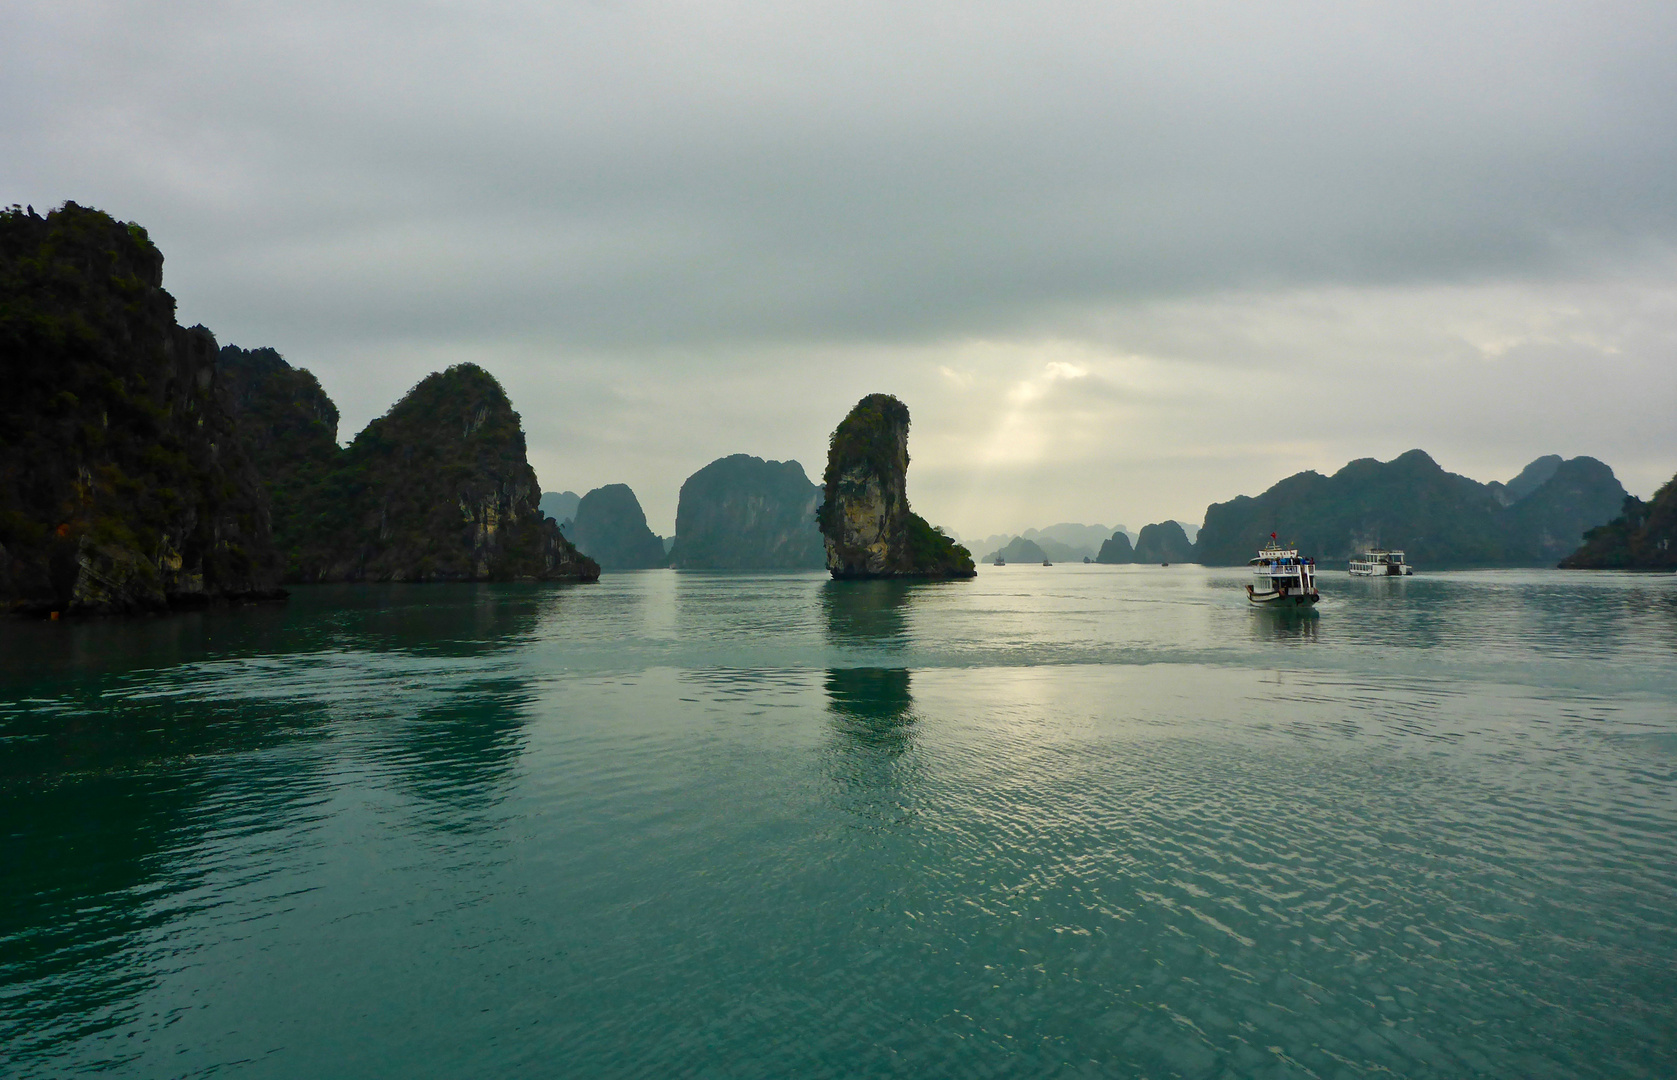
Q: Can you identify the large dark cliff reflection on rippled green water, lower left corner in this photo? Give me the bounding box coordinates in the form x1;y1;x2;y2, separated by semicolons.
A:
0;690;337;1072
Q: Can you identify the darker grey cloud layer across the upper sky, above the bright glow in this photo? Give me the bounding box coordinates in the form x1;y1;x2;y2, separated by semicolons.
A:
0;3;1677;347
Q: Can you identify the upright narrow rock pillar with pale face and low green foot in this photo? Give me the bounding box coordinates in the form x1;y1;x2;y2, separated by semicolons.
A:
817;394;974;579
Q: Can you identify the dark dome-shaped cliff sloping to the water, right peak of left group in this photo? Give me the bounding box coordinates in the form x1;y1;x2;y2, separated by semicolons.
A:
299;364;599;582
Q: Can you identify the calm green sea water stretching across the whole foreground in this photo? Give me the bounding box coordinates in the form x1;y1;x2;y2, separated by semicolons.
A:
0;565;1677;1077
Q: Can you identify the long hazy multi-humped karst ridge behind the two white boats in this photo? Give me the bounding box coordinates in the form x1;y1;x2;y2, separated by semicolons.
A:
1194;449;1625;567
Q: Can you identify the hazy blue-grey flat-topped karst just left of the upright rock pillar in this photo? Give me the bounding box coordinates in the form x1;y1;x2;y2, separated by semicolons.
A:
669;454;827;570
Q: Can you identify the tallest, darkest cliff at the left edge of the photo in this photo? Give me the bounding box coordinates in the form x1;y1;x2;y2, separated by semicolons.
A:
0;203;283;614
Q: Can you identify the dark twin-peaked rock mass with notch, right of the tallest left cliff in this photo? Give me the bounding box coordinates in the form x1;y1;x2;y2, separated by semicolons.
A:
223;358;599;582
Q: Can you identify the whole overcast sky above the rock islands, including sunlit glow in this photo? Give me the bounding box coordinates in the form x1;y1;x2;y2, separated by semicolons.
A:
0;0;1677;537
